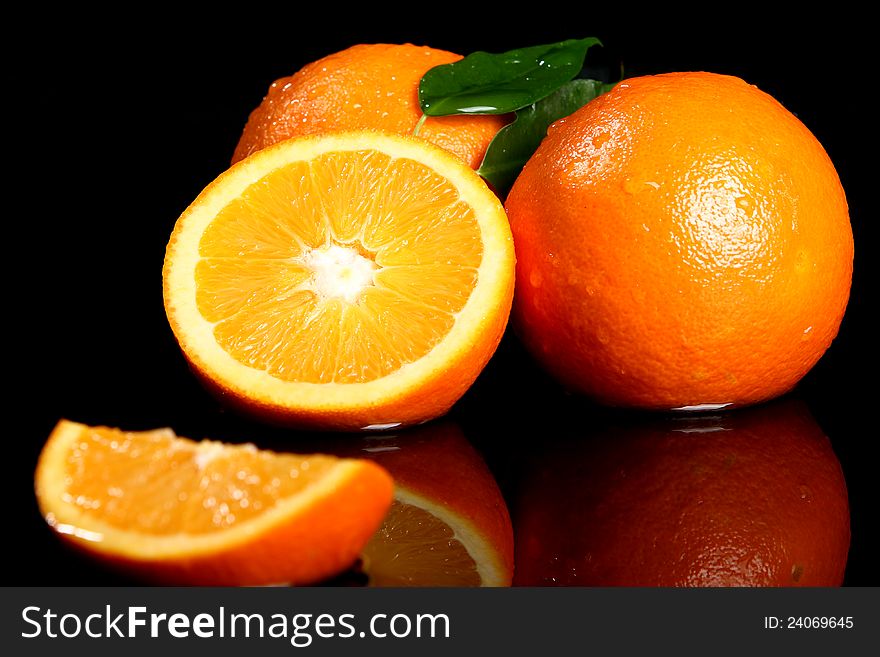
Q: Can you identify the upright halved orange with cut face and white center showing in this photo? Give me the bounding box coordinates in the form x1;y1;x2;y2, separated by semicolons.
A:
164;132;514;430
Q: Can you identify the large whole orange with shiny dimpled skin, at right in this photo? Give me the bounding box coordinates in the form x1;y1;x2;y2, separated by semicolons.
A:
506;73;853;409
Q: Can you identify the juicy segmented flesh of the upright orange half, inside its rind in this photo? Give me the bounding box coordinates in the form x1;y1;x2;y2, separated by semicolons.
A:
196;150;482;383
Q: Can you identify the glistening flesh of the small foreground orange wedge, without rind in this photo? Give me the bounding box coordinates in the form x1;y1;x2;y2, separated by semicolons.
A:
64;428;339;536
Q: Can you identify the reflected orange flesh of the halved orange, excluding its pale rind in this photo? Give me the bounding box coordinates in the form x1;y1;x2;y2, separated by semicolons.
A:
363;500;481;586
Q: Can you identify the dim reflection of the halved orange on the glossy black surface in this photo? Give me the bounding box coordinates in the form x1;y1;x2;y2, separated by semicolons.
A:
344;421;513;587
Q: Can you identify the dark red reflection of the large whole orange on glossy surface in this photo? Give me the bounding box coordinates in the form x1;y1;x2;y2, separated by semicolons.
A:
514;400;850;587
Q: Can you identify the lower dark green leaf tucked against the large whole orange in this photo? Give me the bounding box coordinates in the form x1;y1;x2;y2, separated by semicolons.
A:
477;80;614;198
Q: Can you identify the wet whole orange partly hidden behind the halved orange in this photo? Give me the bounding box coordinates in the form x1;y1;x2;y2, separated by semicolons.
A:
232;43;507;169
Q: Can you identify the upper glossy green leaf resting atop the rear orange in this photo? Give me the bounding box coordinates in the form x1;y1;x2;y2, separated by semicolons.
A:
419;38;601;116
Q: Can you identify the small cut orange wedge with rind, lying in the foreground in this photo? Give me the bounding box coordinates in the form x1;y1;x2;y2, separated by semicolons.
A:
35;420;392;586
